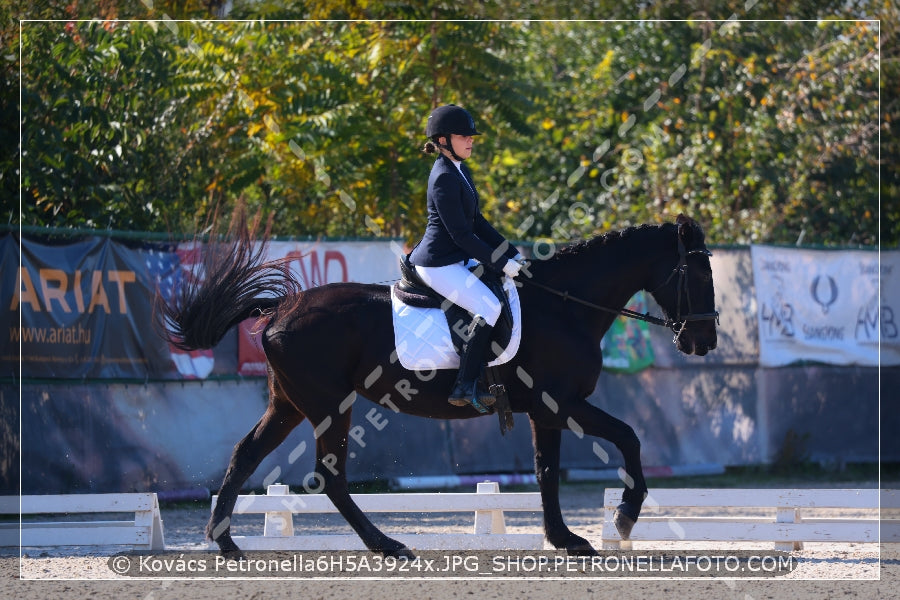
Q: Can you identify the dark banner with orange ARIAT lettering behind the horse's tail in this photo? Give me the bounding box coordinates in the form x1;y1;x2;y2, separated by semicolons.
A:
0;235;192;379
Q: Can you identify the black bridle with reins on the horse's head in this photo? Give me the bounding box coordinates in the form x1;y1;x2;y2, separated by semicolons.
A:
516;236;719;342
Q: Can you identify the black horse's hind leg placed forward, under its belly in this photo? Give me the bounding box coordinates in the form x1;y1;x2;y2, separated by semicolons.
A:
315;410;413;558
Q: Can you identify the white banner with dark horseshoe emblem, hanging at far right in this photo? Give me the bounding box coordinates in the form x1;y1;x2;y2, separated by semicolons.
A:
750;246;900;367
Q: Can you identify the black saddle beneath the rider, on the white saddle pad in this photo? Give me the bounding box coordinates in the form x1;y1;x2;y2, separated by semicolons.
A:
394;255;513;362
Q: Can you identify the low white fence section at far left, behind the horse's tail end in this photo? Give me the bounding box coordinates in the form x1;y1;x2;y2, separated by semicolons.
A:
0;493;165;550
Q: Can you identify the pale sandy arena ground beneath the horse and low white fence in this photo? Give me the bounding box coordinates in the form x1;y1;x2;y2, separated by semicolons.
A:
0;483;900;600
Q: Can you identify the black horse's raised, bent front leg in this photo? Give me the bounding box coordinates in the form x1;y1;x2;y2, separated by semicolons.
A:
536;399;647;540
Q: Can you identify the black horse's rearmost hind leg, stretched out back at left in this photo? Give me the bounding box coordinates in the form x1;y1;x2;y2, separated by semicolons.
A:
206;392;304;557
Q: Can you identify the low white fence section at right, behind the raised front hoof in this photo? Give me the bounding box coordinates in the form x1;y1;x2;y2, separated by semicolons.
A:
602;488;884;551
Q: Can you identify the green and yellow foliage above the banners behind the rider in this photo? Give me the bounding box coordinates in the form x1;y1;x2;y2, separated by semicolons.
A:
7;0;900;245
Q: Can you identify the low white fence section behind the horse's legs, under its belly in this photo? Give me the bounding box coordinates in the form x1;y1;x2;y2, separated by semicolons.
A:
216;481;544;551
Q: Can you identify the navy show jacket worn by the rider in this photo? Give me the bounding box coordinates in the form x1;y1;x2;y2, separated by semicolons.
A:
409;154;517;271
